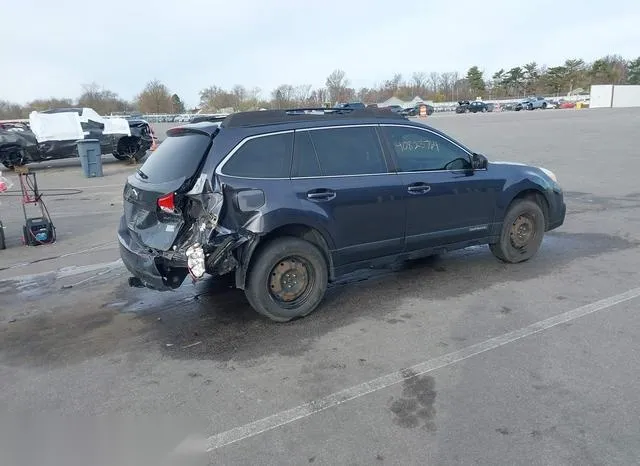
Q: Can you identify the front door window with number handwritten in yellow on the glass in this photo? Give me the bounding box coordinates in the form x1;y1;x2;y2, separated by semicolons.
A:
384;126;471;172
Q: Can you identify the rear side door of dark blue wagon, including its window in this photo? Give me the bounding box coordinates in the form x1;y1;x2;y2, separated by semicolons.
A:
292;125;405;266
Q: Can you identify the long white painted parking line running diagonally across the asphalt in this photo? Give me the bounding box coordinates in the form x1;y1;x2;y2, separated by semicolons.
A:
206;288;640;452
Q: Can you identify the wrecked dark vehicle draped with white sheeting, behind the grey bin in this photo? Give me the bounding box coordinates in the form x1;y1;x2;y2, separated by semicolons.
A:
0;108;154;168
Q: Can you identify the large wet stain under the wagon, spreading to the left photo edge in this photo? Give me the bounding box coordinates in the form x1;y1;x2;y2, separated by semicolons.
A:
0;232;638;370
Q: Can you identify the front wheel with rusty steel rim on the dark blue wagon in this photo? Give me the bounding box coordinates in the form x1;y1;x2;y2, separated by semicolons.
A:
489;199;546;264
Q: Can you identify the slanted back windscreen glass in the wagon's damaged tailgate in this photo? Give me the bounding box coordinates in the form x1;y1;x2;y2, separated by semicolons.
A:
140;132;211;183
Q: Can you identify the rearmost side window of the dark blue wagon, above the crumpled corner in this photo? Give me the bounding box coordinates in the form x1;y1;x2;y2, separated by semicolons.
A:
222;132;293;178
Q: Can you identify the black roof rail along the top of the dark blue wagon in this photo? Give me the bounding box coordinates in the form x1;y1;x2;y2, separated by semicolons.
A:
221;107;406;128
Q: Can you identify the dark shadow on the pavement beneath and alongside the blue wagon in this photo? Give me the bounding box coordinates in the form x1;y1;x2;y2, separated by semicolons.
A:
119;232;638;362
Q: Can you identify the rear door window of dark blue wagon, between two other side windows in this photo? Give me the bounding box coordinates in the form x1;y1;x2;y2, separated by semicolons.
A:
309;126;387;176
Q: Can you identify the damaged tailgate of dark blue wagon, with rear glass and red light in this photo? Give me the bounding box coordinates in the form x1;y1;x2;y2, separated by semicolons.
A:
124;128;212;251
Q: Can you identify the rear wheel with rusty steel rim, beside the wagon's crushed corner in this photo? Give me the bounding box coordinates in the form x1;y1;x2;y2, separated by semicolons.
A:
245;236;329;322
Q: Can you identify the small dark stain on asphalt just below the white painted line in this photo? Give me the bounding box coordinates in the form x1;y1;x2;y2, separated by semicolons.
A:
389;370;437;432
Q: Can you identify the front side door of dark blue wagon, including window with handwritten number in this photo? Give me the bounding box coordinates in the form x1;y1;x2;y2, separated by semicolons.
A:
383;125;504;251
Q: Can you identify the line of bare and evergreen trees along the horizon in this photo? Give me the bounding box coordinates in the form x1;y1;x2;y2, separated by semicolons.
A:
0;55;640;119
